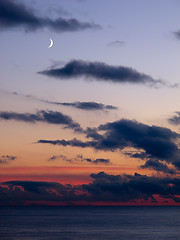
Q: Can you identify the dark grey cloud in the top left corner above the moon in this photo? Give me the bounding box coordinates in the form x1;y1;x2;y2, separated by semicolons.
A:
0;0;100;32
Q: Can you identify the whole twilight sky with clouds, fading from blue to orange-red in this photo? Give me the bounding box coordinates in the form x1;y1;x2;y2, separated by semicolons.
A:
0;0;180;205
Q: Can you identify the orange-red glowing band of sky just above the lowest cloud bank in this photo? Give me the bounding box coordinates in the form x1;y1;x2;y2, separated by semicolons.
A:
0;165;153;185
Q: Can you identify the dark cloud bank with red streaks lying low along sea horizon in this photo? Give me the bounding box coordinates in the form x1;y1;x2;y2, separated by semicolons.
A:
0;172;180;206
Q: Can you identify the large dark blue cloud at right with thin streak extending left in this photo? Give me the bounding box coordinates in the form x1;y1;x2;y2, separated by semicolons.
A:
38;119;180;170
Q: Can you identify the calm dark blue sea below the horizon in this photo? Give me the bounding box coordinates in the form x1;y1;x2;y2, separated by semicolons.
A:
0;207;180;240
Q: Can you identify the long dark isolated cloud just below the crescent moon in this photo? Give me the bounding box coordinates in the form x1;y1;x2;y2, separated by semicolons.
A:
39;60;164;86
